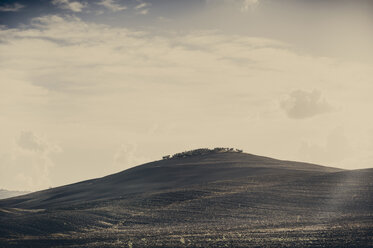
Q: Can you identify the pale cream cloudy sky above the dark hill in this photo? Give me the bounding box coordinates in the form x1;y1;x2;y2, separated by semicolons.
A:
0;0;373;190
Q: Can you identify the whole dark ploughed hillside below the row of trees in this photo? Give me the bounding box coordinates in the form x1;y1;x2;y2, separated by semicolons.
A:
0;152;373;248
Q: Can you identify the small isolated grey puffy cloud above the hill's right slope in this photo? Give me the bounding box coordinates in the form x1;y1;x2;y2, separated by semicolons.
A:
281;90;332;119
